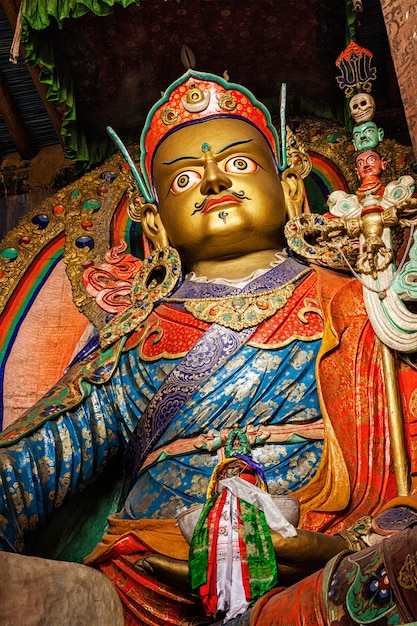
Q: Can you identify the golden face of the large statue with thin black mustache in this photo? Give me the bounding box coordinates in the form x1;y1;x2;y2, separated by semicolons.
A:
154;118;286;267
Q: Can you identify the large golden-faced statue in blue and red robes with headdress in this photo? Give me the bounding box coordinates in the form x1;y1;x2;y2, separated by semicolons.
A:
0;71;417;625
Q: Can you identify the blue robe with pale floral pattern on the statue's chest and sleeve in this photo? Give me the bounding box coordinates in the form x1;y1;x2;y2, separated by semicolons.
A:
0;260;323;551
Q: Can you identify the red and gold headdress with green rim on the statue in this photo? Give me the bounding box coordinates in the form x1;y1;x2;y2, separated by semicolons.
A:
140;70;286;202
